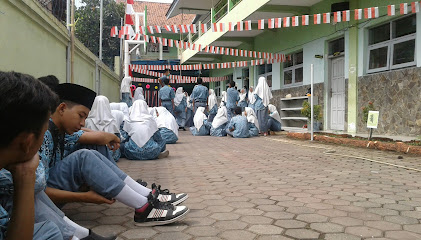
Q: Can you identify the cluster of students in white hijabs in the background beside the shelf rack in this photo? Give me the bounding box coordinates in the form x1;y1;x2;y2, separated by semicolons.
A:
190;77;282;138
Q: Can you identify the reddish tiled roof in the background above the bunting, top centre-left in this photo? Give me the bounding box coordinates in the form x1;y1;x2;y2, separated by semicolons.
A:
117;0;196;27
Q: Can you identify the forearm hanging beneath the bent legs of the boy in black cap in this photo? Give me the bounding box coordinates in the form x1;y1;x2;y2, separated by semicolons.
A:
45;187;115;204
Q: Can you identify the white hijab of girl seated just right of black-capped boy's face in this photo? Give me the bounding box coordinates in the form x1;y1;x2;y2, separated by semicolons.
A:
85;96;120;133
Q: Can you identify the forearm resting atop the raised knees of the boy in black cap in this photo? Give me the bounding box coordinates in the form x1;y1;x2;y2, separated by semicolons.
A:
78;131;120;151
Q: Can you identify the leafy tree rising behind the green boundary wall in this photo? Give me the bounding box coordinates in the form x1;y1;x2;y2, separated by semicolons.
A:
75;0;125;69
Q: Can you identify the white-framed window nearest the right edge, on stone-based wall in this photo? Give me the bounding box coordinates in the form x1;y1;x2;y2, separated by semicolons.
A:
367;15;416;73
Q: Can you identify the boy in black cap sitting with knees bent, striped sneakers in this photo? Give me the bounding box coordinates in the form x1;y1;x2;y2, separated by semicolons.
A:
40;83;188;226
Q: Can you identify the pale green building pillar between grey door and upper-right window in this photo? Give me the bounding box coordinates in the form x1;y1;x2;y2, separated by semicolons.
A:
348;0;359;135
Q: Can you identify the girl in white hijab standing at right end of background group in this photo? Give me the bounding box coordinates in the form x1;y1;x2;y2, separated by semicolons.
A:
254;77;272;136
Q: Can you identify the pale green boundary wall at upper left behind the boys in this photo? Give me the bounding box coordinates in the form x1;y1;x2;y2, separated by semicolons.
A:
0;0;120;101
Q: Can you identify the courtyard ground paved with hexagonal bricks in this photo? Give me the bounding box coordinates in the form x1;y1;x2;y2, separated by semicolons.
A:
64;132;421;240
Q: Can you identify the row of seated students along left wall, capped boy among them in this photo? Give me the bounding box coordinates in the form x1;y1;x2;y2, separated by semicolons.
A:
0;72;189;240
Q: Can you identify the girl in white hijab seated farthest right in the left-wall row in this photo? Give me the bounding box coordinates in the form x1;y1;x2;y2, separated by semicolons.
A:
153;107;178;144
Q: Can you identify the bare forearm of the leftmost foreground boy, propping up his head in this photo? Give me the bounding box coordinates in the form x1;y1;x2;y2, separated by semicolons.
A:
6;154;39;240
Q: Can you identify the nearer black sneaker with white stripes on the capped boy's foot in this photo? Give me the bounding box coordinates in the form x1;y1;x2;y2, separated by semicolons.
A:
134;189;189;227
